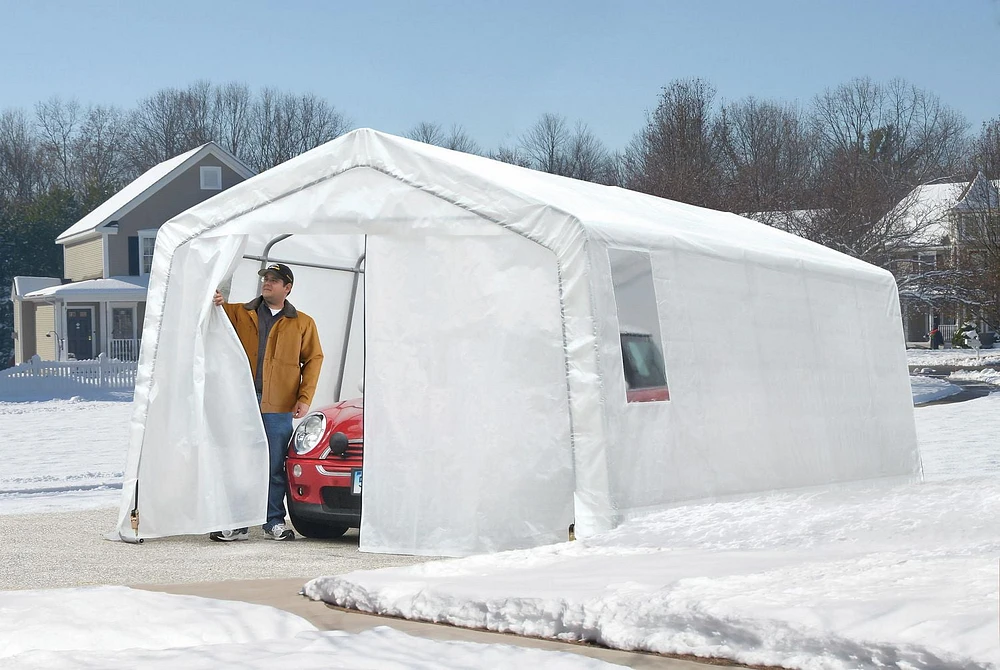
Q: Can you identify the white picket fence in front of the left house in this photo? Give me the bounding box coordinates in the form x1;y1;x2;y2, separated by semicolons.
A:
0;354;136;396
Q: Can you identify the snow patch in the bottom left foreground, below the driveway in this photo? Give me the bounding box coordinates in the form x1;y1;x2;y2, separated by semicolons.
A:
0;586;619;670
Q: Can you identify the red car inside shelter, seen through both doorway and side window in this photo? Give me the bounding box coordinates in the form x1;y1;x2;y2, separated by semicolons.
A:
285;331;670;539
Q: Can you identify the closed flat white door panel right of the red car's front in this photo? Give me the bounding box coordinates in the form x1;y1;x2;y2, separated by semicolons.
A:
361;232;573;556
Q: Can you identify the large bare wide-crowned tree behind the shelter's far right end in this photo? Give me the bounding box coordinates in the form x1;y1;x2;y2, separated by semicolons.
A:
810;78;967;267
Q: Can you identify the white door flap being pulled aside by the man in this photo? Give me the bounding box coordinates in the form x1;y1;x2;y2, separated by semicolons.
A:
119;236;267;538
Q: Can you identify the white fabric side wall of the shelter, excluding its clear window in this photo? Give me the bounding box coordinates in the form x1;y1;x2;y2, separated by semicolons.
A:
598;244;919;514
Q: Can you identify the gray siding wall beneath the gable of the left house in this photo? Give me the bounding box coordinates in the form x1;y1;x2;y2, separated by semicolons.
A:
108;155;243;276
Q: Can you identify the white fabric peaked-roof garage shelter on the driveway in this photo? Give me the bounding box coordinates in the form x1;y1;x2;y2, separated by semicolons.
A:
113;130;920;555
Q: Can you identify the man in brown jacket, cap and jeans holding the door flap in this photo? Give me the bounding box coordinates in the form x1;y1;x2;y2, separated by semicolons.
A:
209;263;323;542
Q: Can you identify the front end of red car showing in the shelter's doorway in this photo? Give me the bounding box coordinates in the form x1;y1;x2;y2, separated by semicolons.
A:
285;398;364;539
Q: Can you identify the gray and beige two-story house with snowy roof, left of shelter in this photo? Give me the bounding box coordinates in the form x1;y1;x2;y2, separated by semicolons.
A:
11;142;254;363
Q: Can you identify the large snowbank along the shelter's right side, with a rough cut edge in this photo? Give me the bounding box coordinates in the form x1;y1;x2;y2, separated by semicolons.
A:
306;394;1000;669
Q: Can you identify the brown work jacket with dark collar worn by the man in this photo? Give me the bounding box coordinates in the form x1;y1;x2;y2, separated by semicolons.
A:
222;296;323;413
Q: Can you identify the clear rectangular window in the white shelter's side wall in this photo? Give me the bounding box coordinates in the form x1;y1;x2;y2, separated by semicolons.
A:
608;249;670;402
